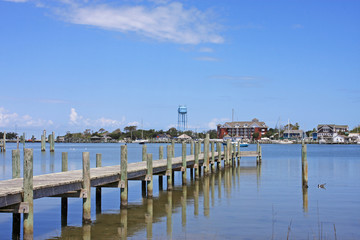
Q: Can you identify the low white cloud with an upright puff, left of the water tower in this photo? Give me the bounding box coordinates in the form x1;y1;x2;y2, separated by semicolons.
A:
69;108;125;127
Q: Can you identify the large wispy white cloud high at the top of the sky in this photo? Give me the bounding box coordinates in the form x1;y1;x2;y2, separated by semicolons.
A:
6;0;224;44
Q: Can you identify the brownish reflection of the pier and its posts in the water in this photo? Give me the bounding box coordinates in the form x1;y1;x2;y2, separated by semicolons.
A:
49;166;261;239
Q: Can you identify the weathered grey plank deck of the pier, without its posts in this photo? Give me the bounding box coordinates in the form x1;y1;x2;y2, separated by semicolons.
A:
0;151;258;208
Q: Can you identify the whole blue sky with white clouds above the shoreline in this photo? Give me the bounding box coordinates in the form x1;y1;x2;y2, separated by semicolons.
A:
0;0;360;136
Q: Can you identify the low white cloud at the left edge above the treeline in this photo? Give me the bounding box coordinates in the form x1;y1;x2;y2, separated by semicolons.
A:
0;107;54;127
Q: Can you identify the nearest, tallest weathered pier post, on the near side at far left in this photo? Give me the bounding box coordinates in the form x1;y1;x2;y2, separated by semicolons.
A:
23;149;34;240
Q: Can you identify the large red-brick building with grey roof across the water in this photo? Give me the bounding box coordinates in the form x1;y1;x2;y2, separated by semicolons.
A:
217;118;268;139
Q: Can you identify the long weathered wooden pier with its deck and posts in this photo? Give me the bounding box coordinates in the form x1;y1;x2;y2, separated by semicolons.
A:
0;136;262;239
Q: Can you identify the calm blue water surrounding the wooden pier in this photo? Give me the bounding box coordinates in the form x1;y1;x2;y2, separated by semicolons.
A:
0;144;360;239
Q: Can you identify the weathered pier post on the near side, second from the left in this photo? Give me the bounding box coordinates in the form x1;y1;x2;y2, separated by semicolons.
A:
82;152;91;224
